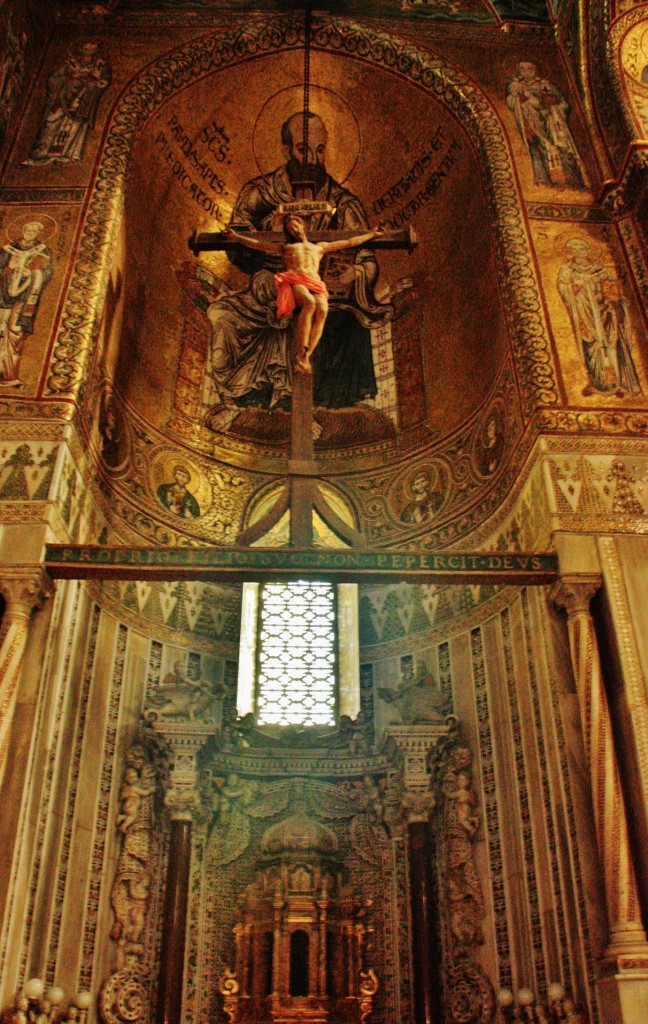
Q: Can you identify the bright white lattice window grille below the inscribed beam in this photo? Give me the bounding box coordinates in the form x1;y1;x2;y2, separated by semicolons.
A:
256;581;337;725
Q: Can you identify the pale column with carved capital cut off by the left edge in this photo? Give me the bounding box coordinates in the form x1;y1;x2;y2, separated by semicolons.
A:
0;566;53;779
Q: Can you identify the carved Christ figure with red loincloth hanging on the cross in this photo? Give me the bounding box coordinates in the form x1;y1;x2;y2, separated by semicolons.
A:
225;216;383;374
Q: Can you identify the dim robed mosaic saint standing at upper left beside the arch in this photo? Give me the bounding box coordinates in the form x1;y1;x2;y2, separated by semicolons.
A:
26;42;112;164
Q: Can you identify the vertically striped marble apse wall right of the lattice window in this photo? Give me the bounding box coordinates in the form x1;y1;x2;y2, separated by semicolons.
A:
363;590;599;1020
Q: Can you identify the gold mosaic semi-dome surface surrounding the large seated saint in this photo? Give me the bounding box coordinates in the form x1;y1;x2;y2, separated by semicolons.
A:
116;40;509;464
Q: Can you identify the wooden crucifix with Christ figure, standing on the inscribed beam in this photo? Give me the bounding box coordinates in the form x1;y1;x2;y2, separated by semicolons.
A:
189;216;418;548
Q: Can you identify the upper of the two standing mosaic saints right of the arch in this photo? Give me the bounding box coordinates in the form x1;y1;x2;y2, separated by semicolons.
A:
507;60;586;188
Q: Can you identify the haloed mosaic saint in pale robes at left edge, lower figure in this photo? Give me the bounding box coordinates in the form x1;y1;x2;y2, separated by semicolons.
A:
0;220;53;387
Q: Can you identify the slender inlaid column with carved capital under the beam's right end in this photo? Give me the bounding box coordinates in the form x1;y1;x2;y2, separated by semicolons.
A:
550;575;646;956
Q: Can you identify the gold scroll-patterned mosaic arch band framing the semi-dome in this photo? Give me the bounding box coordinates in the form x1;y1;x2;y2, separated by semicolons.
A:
46;14;559;419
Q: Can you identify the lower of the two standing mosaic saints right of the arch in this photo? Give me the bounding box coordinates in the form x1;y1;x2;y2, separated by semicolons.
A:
558;238;641;397
